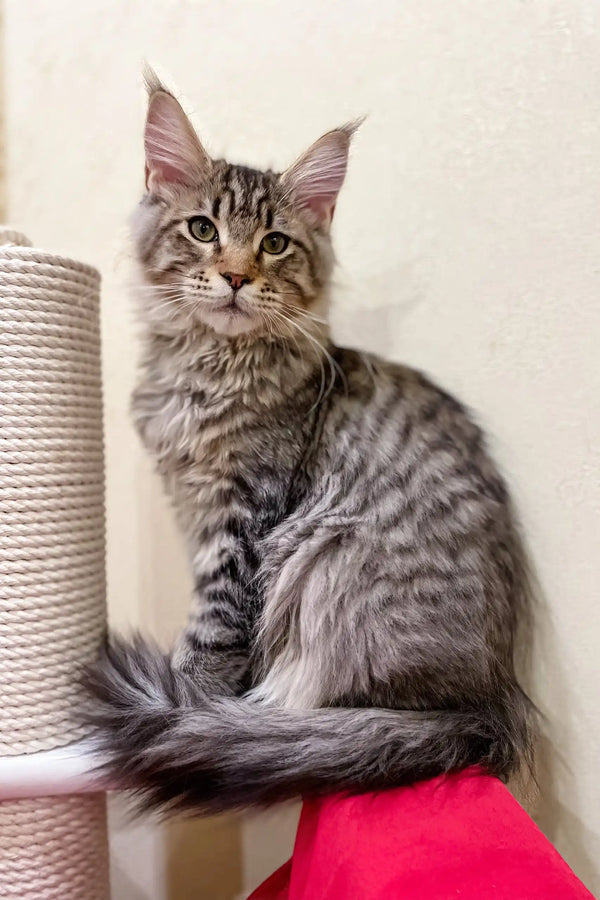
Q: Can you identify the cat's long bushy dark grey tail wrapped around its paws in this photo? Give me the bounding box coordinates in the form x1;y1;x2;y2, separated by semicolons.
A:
87;640;529;812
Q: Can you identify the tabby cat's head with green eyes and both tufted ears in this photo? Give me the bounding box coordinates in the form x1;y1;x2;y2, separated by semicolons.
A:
134;76;354;336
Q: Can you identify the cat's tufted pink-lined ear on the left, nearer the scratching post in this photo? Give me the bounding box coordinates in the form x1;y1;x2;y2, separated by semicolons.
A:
144;76;211;194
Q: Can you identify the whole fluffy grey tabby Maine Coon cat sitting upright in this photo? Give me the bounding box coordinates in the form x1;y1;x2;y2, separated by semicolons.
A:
90;76;531;812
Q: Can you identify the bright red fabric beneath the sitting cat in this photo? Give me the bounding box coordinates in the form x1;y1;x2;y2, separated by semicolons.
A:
249;769;593;900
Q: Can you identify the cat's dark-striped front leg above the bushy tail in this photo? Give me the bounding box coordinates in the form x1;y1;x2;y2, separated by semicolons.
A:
173;528;256;694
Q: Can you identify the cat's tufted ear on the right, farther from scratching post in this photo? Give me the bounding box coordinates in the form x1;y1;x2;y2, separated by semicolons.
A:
281;122;360;228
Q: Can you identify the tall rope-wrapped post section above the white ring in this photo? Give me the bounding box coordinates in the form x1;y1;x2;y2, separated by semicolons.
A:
0;229;106;756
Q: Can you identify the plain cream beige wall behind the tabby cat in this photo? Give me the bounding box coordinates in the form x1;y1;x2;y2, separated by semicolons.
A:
5;0;600;898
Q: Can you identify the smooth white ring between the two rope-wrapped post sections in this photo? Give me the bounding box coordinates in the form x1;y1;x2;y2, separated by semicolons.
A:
0;741;108;802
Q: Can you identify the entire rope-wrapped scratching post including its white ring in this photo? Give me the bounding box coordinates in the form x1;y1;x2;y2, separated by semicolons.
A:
0;229;109;900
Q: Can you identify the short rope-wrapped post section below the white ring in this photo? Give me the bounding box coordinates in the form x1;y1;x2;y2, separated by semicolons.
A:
0;794;110;900
